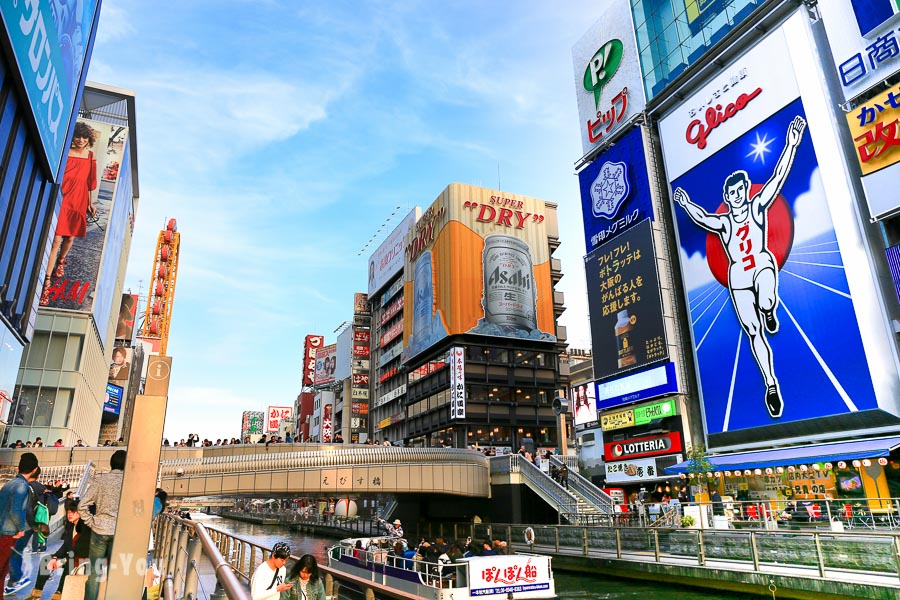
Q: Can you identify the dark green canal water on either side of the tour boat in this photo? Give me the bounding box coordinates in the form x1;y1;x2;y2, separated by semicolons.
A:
192;514;760;600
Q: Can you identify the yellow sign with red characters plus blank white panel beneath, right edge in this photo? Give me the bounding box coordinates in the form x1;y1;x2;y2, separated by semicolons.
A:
846;79;900;219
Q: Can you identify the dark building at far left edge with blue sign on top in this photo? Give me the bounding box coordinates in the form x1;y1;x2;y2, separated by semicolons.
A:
0;0;100;440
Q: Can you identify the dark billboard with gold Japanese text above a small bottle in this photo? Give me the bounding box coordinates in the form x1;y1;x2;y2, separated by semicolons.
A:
584;220;669;379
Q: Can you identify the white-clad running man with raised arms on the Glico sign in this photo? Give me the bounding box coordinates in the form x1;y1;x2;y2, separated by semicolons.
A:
674;116;806;419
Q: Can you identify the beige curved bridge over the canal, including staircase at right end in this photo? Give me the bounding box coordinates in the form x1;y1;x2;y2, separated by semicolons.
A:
0;444;612;524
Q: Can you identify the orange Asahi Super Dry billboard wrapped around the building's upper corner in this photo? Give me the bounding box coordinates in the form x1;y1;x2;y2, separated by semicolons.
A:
403;183;556;362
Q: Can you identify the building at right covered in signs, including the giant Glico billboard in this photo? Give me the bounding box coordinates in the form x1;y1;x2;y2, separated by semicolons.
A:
575;0;900;510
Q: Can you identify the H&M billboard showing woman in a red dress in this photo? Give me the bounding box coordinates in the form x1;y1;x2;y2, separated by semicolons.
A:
40;119;130;322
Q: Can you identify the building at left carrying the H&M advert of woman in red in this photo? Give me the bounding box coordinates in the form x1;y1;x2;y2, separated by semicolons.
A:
7;83;140;444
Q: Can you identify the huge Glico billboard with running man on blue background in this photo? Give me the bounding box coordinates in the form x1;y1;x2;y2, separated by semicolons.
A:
660;12;898;445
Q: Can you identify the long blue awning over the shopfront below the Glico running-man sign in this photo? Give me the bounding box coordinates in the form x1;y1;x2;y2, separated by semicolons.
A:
666;437;900;475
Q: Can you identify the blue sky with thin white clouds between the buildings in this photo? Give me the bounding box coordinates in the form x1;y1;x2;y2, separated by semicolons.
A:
88;0;605;440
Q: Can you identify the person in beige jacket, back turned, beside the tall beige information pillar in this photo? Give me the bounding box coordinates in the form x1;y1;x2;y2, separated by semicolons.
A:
78;450;127;600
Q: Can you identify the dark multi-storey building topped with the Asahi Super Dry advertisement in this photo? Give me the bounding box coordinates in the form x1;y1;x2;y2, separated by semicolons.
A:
370;183;566;452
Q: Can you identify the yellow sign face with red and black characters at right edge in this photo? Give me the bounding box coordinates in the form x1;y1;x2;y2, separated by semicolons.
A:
847;80;900;175
